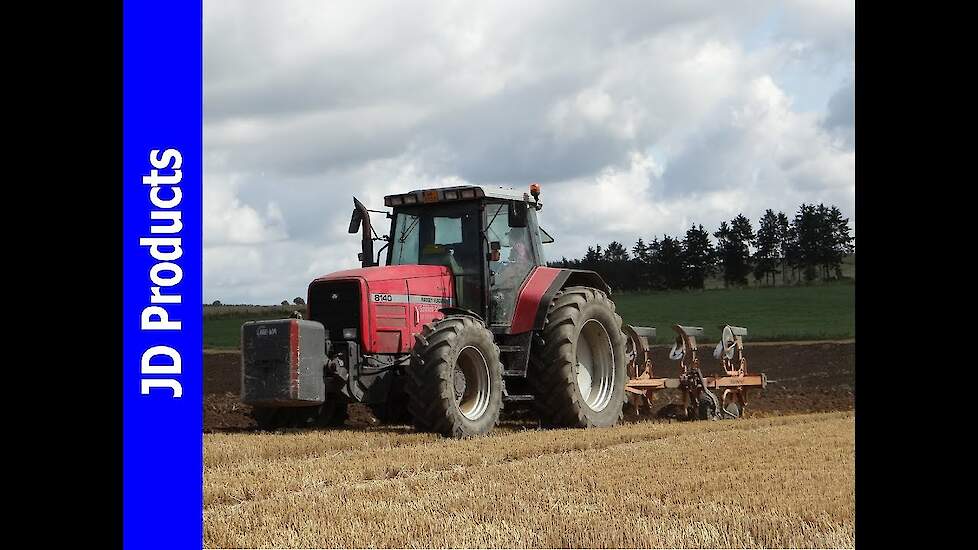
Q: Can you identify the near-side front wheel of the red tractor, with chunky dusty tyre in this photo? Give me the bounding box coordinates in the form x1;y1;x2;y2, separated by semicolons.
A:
404;315;503;437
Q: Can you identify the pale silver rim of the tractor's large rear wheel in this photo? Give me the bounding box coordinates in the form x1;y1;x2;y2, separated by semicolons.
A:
577;319;615;411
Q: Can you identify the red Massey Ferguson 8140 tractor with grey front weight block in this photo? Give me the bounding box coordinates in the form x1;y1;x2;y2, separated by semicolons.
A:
242;185;628;437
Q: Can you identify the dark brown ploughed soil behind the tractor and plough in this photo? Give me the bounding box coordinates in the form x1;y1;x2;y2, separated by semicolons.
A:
204;342;856;432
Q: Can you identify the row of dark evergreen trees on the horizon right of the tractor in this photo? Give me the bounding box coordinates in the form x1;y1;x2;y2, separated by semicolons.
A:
547;204;855;290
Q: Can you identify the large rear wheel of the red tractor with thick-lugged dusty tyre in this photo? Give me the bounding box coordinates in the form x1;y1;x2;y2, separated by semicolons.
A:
527;287;628;428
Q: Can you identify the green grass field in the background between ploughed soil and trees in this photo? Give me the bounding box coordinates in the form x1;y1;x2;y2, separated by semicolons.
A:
204;283;856;349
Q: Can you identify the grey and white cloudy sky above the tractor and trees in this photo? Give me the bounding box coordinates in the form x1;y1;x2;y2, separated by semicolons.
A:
204;0;856;303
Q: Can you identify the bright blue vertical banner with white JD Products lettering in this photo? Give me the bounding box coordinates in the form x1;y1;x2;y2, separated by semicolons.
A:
122;0;203;548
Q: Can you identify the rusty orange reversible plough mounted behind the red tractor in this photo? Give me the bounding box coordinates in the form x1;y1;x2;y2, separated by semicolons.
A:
622;325;767;420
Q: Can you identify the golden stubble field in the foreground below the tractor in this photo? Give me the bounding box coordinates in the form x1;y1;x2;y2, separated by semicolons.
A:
204;412;855;548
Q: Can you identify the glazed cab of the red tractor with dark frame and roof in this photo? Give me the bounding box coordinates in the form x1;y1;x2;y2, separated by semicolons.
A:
351;186;552;327
